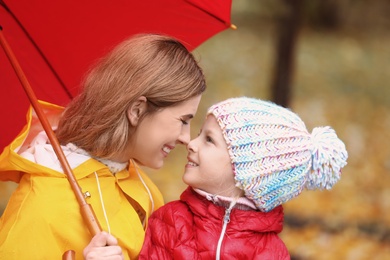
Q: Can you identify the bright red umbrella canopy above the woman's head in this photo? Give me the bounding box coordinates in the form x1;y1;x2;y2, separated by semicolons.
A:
0;0;232;151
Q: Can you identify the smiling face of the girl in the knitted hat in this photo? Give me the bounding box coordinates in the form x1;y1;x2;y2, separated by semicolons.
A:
183;115;242;197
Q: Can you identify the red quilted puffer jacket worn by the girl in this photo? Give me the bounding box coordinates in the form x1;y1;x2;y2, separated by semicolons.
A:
139;188;290;260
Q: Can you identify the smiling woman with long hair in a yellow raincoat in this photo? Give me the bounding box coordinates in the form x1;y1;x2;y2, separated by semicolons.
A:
0;35;206;259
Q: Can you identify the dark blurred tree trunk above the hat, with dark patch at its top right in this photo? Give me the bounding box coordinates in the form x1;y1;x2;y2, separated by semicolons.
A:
271;0;352;107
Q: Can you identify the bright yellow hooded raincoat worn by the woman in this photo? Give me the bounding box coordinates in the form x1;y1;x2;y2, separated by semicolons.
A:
0;102;163;260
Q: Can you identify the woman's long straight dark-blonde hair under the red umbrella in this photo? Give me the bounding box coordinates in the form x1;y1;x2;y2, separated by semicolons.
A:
56;34;206;158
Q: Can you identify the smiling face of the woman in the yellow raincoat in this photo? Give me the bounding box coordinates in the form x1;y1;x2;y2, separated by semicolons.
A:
128;95;201;169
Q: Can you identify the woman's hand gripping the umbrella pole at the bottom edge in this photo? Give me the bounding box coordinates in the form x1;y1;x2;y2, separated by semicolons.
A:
83;231;124;260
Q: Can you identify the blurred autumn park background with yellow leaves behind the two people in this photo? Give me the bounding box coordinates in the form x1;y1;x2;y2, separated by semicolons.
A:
0;0;390;260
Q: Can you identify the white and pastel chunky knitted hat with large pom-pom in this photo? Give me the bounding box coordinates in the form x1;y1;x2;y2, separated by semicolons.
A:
207;97;348;212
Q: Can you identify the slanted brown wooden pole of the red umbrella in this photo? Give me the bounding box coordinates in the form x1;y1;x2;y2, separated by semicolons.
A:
0;26;102;255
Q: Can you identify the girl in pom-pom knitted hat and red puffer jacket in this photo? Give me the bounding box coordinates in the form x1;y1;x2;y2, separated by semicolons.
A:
139;97;348;259
